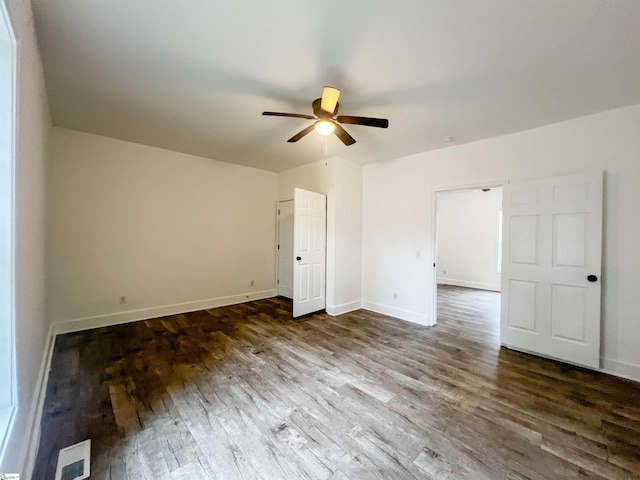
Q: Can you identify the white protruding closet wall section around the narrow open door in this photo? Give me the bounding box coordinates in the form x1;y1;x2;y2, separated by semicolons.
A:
278;157;362;315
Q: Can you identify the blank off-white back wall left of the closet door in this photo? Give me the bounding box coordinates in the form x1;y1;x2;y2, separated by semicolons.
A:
48;128;277;331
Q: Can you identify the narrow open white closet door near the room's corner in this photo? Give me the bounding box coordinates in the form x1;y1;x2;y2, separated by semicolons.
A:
293;188;327;317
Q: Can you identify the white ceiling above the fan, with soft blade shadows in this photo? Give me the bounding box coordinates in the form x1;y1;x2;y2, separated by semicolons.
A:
32;0;640;172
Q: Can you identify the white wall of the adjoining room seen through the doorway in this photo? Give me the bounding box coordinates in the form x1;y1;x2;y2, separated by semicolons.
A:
436;188;502;291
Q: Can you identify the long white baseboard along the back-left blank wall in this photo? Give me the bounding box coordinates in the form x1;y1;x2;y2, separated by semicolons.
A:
53;290;276;335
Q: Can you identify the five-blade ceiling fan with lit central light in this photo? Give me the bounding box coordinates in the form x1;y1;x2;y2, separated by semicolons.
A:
262;87;389;146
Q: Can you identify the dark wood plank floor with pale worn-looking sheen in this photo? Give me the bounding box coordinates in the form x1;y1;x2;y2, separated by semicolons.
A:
33;287;640;480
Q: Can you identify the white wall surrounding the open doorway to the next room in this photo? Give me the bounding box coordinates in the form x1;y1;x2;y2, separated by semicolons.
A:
363;105;640;379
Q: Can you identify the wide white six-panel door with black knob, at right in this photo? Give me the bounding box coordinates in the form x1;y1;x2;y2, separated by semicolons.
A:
500;172;602;368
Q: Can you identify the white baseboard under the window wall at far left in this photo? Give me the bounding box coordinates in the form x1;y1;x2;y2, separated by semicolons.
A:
22;325;55;480
